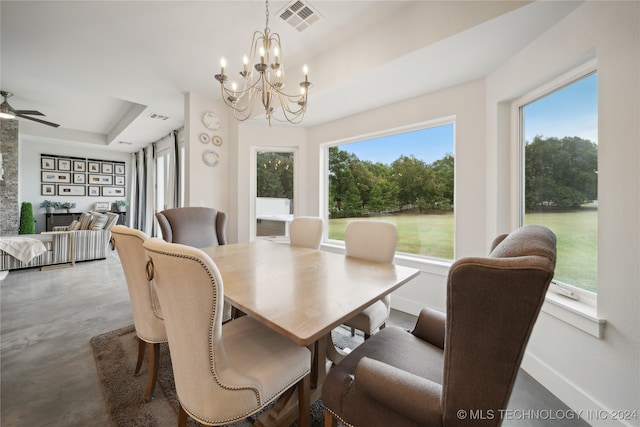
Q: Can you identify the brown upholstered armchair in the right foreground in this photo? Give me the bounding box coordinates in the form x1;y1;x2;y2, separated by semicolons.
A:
322;225;556;427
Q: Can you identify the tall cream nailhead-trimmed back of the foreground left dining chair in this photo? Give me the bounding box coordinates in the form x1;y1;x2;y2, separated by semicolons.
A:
144;237;259;417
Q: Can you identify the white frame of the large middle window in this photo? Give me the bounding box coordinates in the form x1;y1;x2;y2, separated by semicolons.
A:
319;115;457;264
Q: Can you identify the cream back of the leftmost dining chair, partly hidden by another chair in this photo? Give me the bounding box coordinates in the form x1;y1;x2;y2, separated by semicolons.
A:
111;225;167;343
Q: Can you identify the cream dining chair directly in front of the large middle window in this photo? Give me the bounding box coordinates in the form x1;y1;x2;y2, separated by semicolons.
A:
344;220;398;339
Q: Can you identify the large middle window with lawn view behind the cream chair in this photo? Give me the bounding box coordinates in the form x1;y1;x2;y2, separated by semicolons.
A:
326;120;454;259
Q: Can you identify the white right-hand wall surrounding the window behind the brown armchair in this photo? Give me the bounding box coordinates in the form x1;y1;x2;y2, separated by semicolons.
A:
486;2;640;425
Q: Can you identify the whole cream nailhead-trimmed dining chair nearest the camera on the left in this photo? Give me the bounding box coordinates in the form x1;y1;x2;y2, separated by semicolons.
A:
144;238;311;426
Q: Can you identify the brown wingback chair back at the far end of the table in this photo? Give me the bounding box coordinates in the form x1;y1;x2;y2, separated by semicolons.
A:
156;207;227;248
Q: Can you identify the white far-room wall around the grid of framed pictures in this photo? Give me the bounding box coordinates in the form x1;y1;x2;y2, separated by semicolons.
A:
18;135;131;233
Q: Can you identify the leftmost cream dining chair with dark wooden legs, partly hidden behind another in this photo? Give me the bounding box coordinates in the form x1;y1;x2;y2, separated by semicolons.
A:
111;225;167;402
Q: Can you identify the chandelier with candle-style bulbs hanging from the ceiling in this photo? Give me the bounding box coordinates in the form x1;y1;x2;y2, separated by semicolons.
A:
215;0;311;126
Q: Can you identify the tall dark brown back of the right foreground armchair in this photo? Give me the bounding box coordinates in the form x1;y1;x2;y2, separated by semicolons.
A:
441;225;556;425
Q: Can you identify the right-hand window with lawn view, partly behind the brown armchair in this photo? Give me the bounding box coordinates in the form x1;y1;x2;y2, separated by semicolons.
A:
519;72;598;293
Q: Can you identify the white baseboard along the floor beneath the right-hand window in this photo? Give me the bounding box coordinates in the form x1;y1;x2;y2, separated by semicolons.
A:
521;353;633;427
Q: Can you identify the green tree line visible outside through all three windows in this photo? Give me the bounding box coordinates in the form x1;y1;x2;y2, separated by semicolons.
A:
257;136;598;218
